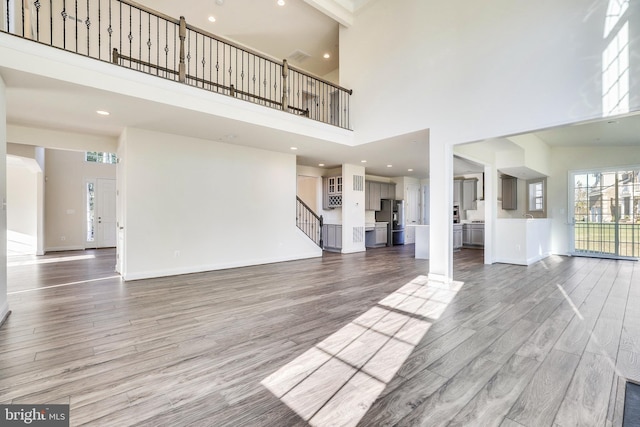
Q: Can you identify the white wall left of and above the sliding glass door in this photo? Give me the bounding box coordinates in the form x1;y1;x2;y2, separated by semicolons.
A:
547;145;640;254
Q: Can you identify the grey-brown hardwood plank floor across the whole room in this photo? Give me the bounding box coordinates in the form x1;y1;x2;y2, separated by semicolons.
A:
0;246;640;427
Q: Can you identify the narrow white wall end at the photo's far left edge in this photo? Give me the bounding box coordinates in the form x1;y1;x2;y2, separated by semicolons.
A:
0;77;9;322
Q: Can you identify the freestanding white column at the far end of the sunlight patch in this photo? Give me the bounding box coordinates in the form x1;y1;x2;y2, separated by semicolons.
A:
429;139;453;282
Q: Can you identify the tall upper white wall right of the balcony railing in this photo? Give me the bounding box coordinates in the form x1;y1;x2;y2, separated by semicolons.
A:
340;0;640;143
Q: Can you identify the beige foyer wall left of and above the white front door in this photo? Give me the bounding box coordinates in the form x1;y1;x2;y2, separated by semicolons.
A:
45;149;116;251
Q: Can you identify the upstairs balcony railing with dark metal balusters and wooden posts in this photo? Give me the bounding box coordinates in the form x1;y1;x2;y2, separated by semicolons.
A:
0;0;352;129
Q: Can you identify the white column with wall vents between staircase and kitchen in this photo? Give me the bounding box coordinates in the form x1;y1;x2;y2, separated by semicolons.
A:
342;164;366;254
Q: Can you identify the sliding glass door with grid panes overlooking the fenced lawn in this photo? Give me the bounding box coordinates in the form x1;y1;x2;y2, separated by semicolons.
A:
569;167;640;258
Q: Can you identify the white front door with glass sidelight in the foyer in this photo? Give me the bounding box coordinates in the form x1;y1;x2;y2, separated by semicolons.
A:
85;178;117;248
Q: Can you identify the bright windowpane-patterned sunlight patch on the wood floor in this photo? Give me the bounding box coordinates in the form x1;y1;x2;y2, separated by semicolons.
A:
262;276;462;426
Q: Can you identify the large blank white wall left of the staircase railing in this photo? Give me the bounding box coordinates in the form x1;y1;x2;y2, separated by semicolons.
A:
118;128;322;280
